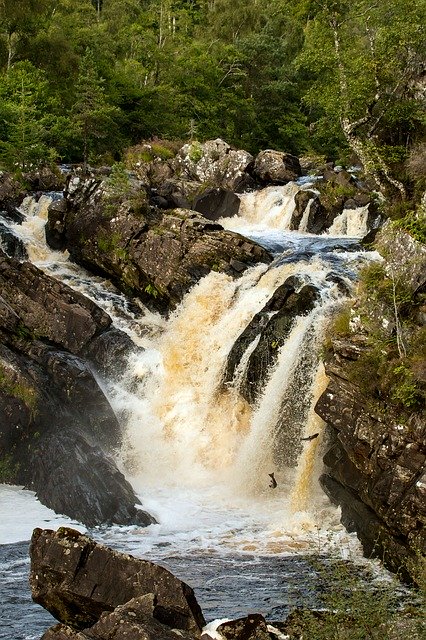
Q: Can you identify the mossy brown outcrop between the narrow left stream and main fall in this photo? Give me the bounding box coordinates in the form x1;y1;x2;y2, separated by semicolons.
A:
46;178;271;312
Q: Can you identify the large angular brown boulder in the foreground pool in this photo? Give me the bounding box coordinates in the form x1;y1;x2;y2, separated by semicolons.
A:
30;528;205;640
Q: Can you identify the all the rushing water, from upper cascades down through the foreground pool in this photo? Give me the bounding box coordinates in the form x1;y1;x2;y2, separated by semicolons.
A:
0;183;402;640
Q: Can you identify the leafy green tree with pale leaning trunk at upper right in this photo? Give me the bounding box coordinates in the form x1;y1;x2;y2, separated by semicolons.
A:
300;0;426;198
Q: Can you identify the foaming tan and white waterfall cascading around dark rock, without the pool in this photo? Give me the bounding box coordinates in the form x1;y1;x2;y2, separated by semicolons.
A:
0;183;380;556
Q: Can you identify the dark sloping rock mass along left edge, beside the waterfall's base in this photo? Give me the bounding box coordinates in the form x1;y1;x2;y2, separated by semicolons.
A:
0;251;153;526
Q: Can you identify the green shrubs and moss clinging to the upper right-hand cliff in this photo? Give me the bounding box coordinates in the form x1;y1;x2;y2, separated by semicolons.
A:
348;262;426;414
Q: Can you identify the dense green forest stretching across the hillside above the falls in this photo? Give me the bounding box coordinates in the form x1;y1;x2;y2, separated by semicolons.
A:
0;0;426;198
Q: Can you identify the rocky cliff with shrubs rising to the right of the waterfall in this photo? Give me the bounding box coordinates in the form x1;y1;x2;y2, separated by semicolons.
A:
316;226;426;581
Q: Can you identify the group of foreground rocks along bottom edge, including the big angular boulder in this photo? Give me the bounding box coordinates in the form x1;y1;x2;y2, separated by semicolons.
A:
30;528;314;640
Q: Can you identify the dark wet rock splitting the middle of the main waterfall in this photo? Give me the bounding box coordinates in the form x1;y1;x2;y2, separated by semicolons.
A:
223;276;319;403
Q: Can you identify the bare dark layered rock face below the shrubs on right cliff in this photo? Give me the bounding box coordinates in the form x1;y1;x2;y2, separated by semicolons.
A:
315;341;426;580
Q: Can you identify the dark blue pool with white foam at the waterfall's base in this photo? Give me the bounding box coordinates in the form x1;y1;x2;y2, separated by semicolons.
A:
0;485;410;640
